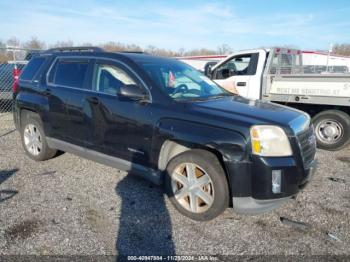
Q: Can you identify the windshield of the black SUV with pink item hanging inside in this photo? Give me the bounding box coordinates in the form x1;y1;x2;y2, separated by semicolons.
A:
141;59;232;100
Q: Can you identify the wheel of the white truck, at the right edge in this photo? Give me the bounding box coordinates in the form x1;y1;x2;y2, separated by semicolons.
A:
312;110;350;151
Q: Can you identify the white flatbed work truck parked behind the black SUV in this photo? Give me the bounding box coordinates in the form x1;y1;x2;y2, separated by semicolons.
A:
207;48;350;150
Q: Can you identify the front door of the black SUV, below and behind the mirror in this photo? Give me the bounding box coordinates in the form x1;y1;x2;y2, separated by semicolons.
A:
88;59;153;165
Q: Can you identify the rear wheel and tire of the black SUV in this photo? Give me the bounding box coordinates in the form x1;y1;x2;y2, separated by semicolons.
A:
20;111;57;161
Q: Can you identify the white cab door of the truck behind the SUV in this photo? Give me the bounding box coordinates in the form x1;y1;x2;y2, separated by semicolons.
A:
212;50;266;99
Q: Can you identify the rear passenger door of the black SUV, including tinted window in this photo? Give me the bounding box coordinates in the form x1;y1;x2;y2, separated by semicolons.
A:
47;57;92;146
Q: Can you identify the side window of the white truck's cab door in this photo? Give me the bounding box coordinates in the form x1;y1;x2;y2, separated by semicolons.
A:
214;53;259;79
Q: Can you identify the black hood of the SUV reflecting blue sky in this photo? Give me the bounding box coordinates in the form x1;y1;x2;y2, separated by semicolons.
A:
189;96;310;134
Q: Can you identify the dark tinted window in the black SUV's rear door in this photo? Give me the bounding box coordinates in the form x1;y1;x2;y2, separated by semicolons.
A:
50;60;88;88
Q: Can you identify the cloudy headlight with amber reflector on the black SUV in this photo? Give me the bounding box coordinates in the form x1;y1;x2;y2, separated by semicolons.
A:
250;125;292;156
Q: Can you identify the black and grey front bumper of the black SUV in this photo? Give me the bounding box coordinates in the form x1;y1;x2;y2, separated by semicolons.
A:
226;156;316;214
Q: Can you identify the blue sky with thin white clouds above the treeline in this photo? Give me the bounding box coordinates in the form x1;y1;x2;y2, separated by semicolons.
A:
0;0;350;50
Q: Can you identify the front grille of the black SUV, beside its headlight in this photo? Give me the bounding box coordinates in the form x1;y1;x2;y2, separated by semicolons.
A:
297;125;316;169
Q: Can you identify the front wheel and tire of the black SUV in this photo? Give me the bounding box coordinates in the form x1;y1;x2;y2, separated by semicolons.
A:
165;149;230;221
